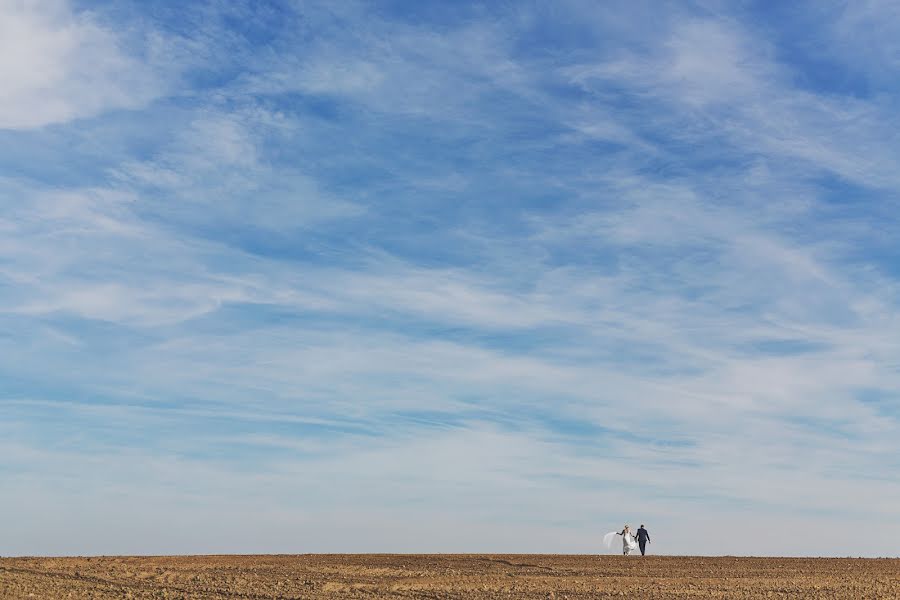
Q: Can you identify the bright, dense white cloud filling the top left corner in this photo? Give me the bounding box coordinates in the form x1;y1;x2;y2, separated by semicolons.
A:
0;0;184;129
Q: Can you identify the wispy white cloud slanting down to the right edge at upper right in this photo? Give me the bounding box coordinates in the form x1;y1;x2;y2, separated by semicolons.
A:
564;18;898;189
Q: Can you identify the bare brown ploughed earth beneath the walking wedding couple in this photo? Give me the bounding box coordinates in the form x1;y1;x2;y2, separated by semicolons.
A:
0;554;900;600
